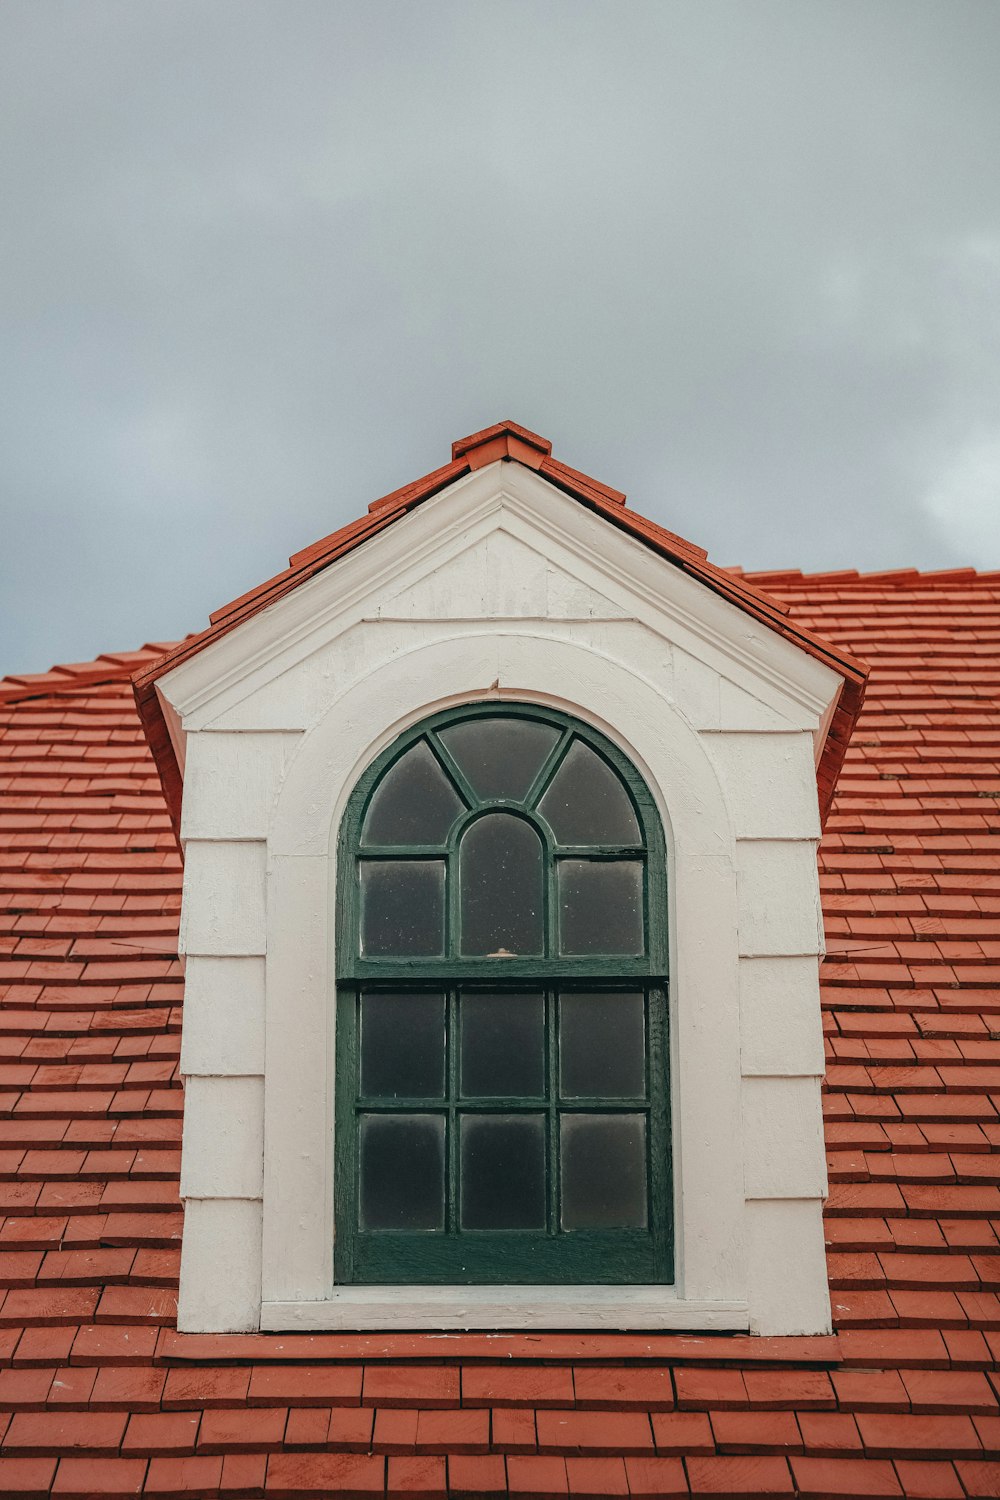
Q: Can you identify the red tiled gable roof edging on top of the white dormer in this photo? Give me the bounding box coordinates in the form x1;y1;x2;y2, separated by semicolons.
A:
133;422;867;831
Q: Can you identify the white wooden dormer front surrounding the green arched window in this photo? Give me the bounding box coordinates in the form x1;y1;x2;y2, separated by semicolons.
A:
157;441;843;1335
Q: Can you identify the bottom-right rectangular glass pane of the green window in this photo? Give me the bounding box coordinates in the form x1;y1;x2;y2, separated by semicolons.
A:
561;1115;646;1229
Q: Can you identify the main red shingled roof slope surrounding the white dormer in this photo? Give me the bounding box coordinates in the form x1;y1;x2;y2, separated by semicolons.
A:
0;575;1000;1500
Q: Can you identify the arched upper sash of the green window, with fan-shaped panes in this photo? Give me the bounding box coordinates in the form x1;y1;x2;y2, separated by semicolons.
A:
337;704;666;978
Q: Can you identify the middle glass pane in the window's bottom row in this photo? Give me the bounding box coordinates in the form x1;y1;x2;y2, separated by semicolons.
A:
462;1115;546;1229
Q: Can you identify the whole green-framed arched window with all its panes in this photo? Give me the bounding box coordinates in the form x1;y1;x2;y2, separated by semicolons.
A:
334;704;673;1284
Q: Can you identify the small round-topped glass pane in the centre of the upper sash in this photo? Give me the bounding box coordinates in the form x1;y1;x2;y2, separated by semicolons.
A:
460;813;543;956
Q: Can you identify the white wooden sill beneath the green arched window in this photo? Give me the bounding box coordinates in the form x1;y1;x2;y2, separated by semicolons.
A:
261;1286;750;1332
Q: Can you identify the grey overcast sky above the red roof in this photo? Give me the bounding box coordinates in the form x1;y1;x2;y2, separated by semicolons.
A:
0;0;1000;672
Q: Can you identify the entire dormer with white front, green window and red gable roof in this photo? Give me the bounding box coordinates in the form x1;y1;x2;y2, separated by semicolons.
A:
144;423;864;1334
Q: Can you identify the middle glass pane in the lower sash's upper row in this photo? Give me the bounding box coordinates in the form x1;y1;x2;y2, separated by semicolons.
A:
462;995;546;1098
